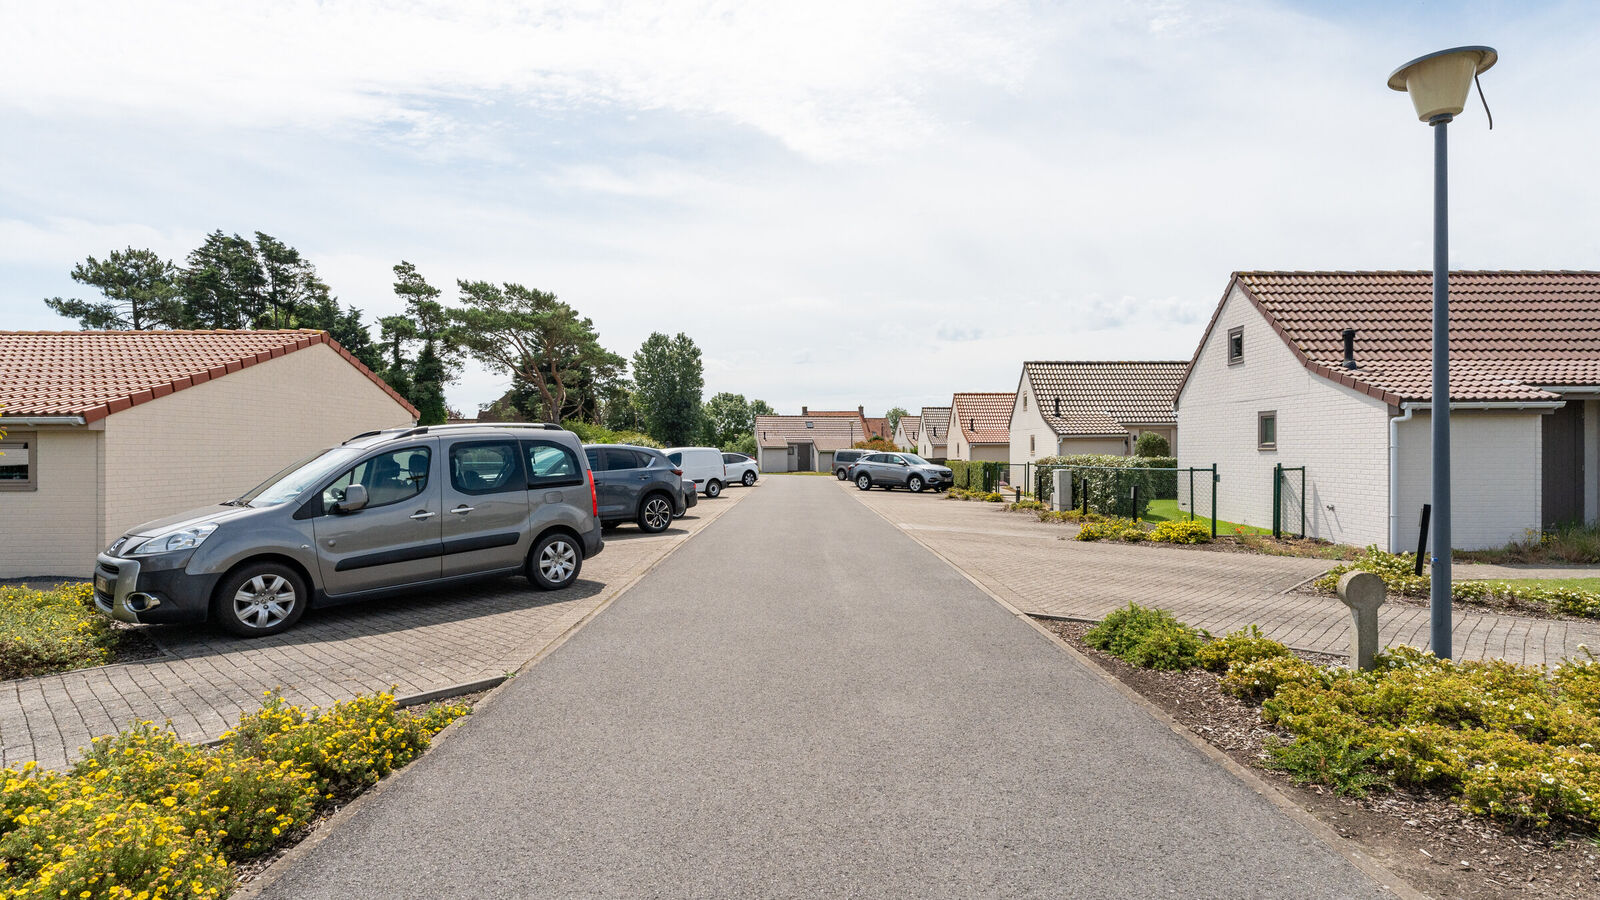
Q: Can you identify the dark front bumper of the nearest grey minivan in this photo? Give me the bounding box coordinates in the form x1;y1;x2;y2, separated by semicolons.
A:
94;551;221;625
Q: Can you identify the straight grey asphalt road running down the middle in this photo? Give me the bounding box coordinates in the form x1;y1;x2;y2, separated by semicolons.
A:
266;476;1384;900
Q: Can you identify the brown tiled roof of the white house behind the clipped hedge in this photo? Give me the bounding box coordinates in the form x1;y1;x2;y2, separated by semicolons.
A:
1022;360;1189;436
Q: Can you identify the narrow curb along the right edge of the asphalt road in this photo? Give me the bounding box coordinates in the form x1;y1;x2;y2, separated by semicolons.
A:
862;486;1430;900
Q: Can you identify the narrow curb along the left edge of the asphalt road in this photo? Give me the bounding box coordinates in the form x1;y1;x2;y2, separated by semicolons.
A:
233;482;760;900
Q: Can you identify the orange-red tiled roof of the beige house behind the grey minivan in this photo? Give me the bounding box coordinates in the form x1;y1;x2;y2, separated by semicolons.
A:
0;330;416;423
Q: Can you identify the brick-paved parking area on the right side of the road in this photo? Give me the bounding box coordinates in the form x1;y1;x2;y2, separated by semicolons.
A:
840;484;1600;665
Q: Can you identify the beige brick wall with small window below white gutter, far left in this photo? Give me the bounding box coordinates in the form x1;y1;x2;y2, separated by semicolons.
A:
0;426;109;578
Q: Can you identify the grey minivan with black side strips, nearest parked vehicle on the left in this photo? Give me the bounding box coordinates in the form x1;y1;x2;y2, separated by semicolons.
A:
94;424;605;636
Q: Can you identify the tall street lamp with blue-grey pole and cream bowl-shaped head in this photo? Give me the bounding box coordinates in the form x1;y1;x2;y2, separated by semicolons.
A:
1389;46;1499;660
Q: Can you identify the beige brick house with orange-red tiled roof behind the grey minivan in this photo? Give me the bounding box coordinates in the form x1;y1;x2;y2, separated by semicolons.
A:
0;330;418;577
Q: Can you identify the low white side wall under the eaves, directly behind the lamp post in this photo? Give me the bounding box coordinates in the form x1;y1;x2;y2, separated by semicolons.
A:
1378;410;1544;549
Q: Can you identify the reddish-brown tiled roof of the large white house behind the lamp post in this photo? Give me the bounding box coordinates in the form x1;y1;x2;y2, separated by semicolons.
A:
1235;271;1600;402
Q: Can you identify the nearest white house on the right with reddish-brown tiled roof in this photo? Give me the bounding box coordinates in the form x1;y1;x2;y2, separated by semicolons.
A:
1178;272;1600;549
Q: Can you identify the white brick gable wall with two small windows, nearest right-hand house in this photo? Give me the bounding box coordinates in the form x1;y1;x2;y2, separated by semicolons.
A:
1178;287;1389;546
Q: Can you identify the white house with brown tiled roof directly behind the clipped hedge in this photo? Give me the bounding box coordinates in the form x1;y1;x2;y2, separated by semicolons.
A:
1011;360;1189;466
